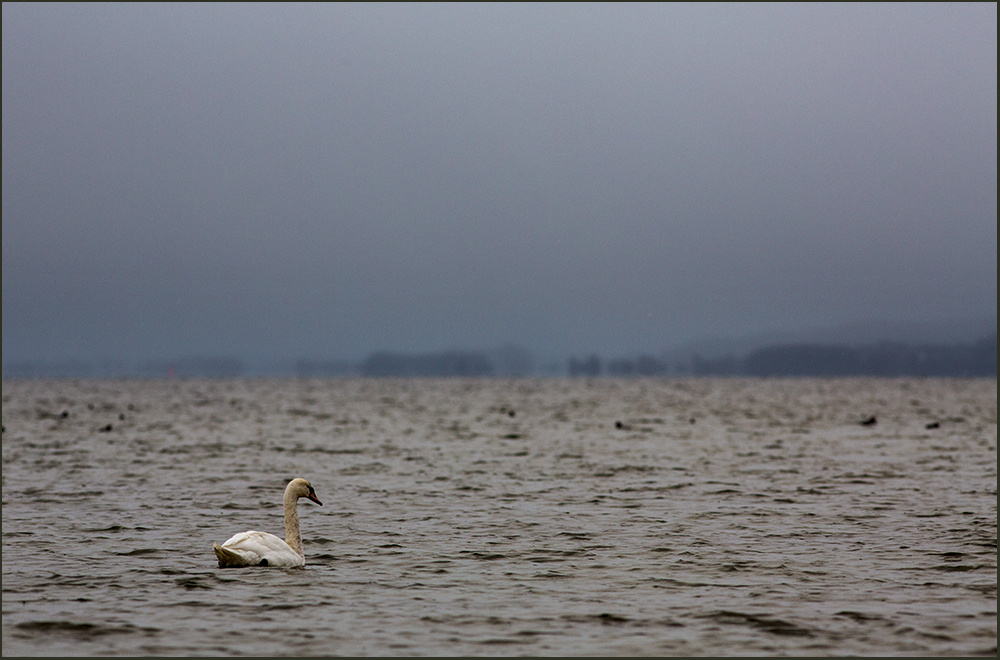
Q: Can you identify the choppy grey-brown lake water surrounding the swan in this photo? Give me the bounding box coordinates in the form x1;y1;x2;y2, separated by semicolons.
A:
3;379;997;655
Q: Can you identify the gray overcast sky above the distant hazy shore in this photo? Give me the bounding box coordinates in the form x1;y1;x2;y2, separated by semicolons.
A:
2;3;997;362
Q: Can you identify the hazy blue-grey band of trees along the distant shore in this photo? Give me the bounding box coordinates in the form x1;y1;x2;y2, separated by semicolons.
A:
3;332;997;378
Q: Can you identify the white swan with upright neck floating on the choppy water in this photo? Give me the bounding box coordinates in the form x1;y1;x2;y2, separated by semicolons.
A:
212;479;323;568
